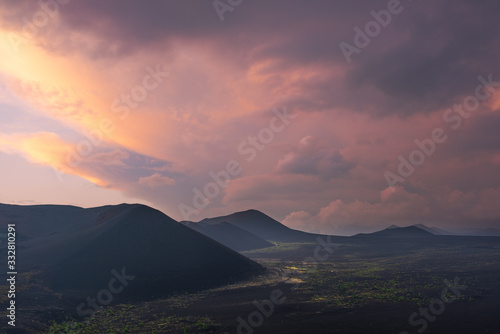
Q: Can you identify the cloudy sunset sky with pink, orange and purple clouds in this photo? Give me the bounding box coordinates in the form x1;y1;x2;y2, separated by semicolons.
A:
0;0;500;235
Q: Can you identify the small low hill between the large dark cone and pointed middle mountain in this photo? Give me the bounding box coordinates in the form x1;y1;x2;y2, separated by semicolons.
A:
181;221;273;251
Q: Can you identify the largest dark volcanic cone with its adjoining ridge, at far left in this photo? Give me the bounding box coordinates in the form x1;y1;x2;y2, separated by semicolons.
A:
0;204;262;301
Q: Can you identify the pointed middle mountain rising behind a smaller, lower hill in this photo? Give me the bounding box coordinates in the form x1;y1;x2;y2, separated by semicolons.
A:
199;210;343;242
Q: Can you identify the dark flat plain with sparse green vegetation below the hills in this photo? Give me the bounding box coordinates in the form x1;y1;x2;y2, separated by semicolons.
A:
1;236;500;334
